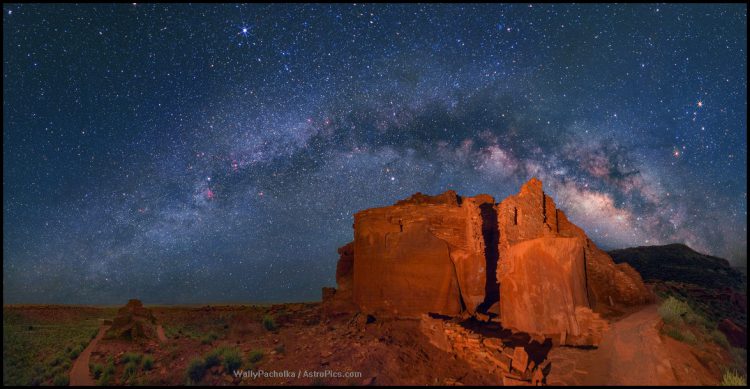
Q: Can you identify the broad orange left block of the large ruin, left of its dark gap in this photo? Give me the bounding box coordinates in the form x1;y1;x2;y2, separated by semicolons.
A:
353;191;494;317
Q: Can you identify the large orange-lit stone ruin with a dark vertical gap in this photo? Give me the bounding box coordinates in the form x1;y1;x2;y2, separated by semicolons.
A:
323;178;652;346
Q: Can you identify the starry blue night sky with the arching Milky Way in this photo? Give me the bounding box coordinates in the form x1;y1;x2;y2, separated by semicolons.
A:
3;3;747;304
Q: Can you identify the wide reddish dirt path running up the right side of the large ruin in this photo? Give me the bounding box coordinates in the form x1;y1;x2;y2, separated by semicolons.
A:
547;305;679;385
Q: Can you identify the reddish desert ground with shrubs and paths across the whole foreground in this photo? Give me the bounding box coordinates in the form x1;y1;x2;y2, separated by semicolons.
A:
3;290;747;385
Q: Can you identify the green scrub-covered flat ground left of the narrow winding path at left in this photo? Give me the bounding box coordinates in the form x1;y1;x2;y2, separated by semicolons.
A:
3;307;116;386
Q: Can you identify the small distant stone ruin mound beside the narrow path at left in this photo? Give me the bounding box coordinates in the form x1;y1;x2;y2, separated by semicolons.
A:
104;299;157;340
